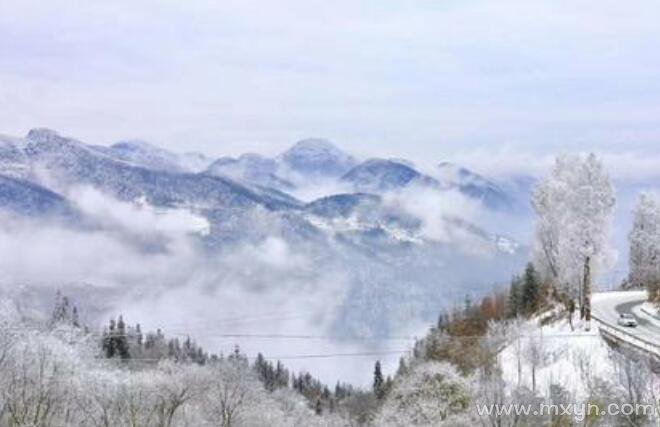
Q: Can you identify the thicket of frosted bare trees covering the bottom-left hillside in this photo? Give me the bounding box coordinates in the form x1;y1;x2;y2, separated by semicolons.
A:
0;298;358;427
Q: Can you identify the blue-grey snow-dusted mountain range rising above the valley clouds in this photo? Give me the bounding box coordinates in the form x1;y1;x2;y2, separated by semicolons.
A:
0;129;525;342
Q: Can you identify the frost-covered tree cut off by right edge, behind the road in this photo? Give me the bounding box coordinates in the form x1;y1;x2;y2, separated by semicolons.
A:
628;193;660;300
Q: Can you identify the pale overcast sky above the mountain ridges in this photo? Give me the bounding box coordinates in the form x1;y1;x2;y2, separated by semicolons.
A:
0;0;660;177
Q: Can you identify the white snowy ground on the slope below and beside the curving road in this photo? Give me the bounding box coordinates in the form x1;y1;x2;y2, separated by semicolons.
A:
499;291;660;406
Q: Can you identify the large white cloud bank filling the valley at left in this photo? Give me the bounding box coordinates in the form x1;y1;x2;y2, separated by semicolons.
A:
0;187;361;381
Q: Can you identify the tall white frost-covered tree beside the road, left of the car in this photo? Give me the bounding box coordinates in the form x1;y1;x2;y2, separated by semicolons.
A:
532;154;616;325
